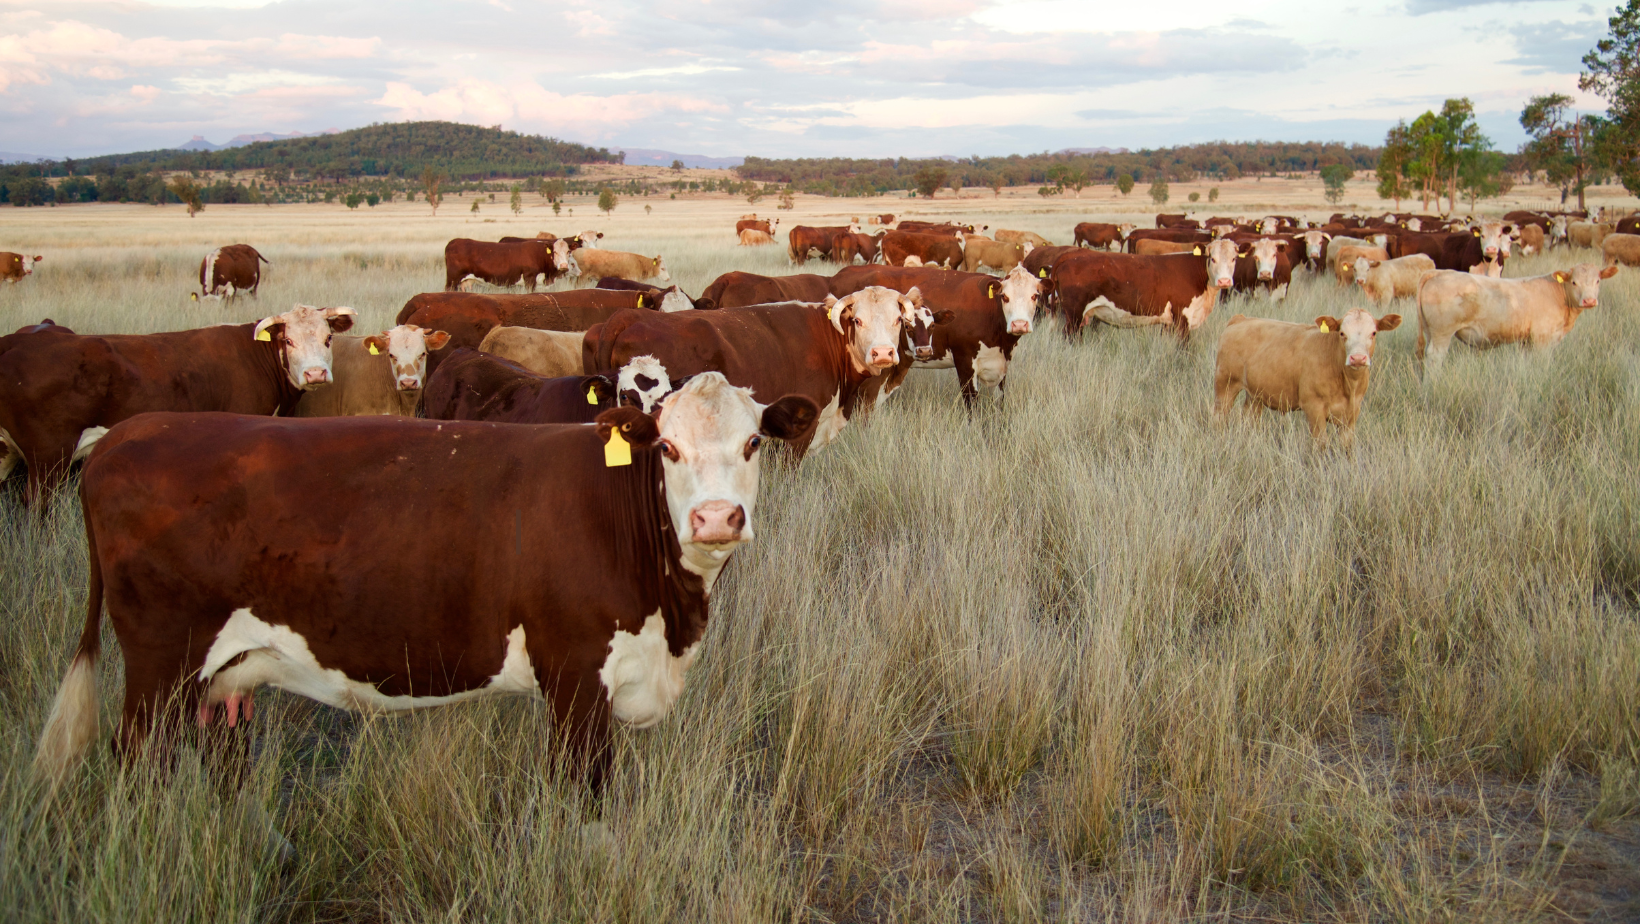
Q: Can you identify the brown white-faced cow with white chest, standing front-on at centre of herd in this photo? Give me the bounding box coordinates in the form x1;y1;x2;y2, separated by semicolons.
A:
831;266;1041;404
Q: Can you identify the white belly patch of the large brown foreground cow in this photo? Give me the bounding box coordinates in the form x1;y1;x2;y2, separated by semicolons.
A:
198;607;544;712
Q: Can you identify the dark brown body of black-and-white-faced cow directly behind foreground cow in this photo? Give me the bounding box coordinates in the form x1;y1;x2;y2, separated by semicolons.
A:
421;343;619;423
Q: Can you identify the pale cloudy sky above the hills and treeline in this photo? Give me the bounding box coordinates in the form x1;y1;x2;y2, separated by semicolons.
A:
0;0;1612;158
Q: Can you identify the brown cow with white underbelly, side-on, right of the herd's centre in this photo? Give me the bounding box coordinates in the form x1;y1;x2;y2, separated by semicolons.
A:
1051;240;1237;341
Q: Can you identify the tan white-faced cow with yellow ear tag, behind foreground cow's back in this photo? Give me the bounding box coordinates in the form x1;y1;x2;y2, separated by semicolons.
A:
292;325;449;417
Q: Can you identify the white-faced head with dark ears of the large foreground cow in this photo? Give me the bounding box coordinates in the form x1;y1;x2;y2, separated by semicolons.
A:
639;373;820;580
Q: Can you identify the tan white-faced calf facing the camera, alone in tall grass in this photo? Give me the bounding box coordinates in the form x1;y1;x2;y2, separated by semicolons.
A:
1214;309;1401;446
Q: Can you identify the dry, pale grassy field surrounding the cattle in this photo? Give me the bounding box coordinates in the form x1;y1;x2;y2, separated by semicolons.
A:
0;197;1640;922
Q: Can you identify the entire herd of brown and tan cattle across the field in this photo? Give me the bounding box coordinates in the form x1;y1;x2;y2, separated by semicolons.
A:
0;202;1613;823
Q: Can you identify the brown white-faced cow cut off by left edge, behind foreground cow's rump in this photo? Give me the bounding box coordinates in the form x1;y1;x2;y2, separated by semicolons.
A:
0;305;356;504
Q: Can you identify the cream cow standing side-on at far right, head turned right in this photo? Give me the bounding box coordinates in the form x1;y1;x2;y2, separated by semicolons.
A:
1417;263;1617;371
